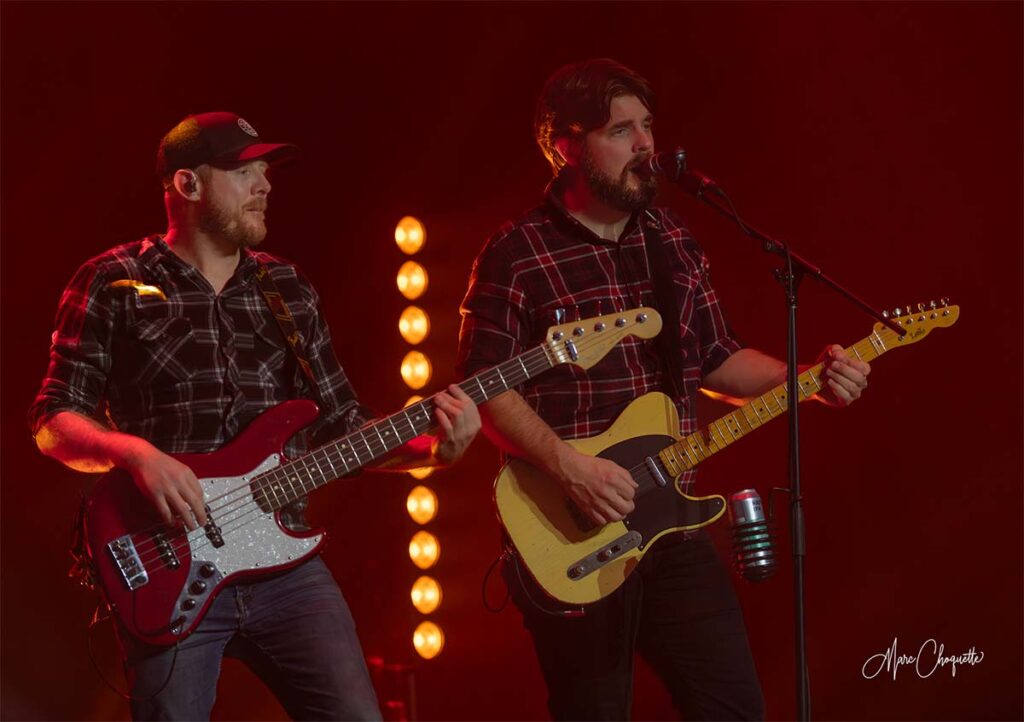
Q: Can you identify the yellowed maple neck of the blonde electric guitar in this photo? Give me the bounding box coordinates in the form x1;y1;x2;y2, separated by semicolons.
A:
658;327;900;477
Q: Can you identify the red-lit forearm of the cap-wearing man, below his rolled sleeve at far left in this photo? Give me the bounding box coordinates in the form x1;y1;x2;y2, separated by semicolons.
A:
36;411;151;473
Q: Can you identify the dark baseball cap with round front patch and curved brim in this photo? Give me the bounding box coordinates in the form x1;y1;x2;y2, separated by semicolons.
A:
157;113;299;177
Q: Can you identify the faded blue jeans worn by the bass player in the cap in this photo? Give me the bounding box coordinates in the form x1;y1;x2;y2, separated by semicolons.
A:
120;556;381;720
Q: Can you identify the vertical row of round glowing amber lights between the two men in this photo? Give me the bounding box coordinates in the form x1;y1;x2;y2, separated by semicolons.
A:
394;216;444;660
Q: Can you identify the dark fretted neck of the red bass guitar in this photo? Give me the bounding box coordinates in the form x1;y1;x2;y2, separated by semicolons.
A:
254;344;559;510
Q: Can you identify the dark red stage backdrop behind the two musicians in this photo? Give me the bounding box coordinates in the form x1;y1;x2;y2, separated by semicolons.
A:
2;2;1024;720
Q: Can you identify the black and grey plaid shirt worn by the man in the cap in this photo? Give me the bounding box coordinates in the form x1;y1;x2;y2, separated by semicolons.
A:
29;237;370;454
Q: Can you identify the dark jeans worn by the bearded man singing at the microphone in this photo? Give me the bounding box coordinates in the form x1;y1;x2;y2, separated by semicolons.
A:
505;535;764;720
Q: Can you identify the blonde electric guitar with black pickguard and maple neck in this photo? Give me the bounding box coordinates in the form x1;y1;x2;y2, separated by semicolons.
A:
495;301;959;604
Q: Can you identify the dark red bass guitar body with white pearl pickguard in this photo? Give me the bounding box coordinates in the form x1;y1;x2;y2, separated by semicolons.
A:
84;400;327;646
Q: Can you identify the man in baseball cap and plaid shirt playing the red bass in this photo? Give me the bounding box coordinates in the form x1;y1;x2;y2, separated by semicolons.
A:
30;113;480;720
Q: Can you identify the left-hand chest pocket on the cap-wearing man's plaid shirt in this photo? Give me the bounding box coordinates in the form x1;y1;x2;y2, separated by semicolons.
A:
121;316;202;385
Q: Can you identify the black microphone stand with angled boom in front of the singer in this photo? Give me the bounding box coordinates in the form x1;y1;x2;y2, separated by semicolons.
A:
654;150;906;720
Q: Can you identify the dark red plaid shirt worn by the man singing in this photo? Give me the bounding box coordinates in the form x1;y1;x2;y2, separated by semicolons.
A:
458;192;740;481
